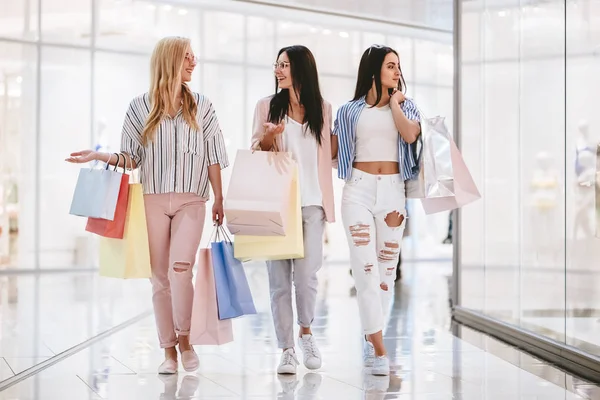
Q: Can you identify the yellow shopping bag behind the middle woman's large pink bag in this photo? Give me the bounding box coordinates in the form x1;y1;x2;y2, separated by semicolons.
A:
233;168;304;261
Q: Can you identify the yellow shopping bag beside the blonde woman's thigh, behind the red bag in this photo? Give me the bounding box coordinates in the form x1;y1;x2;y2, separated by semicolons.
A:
100;183;152;279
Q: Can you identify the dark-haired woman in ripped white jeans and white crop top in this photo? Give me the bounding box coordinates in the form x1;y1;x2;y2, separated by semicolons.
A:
332;45;421;375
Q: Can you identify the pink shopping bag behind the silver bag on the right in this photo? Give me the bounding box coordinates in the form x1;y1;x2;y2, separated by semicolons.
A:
421;139;481;214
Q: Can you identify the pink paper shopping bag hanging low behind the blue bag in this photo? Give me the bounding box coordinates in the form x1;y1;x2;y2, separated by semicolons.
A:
190;249;233;345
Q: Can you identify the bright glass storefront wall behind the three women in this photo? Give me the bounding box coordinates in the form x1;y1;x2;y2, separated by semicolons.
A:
0;0;452;269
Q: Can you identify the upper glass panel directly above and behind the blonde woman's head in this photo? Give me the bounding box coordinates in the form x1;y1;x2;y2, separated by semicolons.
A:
96;0;202;55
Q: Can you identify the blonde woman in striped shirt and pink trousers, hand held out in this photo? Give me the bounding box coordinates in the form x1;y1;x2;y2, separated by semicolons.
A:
67;37;229;374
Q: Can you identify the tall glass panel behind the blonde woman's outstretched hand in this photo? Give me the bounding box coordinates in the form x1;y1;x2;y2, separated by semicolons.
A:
37;47;94;268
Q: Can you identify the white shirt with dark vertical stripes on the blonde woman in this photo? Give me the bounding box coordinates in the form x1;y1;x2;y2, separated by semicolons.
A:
121;93;229;199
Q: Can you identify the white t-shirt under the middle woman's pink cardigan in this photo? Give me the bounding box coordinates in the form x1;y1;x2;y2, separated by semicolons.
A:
282;116;323;207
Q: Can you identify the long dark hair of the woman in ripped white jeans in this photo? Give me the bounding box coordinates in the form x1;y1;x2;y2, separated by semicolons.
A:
353;44;406;105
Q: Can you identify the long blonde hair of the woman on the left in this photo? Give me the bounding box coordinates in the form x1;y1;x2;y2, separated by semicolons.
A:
142;37;199;144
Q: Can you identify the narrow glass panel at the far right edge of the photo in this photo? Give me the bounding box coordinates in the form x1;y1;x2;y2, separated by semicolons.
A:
566;0;600;356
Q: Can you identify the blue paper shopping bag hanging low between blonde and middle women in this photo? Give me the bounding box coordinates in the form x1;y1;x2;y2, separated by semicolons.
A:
210;226;256;320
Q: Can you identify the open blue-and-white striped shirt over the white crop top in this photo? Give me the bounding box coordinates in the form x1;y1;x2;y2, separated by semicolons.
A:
333;97;421;180
